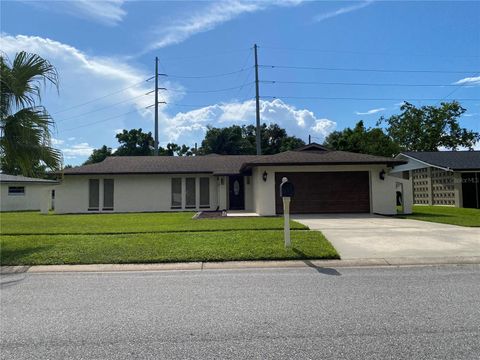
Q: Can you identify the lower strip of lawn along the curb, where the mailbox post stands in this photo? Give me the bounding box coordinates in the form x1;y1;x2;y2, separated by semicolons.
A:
1;230;339;265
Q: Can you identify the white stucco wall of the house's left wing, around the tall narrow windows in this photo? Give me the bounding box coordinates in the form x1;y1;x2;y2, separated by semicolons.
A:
55;174;218;214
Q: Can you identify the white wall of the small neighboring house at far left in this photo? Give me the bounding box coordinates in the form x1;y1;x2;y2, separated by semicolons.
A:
0;183;54;211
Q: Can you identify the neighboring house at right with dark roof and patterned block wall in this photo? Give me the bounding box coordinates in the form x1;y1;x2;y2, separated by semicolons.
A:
393;151;480;209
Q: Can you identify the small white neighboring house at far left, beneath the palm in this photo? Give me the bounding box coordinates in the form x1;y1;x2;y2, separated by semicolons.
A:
0;174;58;211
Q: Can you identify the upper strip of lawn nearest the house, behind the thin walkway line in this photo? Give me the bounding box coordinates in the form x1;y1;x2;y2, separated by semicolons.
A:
0;212;307;235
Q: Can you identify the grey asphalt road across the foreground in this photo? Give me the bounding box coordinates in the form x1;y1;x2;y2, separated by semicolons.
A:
0;266;480;360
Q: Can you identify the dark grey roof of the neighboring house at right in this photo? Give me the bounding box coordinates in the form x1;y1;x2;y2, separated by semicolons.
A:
398;151;480;171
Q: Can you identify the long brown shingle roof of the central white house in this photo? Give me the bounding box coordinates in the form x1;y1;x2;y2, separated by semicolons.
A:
64;150;406;175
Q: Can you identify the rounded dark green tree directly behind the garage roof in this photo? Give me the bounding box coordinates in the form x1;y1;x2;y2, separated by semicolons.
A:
323;121;400;157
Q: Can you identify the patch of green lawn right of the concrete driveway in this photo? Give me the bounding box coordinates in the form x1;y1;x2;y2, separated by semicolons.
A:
399;205;480;226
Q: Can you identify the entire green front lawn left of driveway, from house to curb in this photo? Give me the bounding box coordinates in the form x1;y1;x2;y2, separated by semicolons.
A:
0;213;339;265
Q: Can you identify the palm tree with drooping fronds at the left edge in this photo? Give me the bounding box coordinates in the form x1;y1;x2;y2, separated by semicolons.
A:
0;51;62;176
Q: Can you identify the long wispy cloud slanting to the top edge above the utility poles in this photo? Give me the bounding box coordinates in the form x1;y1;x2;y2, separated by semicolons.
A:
143;0;303;53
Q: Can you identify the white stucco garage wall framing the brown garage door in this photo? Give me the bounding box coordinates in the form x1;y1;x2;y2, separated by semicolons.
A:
252;165;404;216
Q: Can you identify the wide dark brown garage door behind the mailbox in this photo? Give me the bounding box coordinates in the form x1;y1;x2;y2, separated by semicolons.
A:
275;171;370;214
